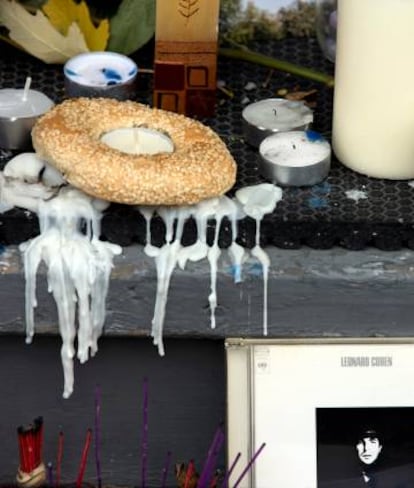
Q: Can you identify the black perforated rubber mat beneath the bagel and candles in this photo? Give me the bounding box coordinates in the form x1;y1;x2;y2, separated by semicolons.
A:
0;38;414;250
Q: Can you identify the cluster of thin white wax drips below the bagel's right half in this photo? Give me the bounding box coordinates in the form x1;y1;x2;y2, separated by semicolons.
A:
139;183;282;346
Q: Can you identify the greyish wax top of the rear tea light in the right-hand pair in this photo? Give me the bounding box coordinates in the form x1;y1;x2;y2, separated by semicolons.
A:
242;98;313;131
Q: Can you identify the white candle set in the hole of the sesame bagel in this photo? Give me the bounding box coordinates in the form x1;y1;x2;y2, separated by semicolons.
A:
101;127;174;154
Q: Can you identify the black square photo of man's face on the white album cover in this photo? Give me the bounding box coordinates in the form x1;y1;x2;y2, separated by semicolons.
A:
316;407;414;488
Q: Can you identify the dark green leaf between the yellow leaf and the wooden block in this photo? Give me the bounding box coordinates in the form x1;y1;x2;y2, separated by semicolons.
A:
106;0;155;54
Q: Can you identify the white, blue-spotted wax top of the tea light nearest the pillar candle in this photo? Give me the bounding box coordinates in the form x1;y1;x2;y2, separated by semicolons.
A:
260;131;331;167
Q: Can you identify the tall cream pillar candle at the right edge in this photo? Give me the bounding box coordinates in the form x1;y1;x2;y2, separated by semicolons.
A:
333;0;414;179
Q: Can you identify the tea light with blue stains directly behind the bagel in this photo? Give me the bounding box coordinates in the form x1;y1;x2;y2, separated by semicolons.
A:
63;51;138;100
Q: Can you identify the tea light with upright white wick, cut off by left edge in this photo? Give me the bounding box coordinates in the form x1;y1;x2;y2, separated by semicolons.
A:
0;77;54;149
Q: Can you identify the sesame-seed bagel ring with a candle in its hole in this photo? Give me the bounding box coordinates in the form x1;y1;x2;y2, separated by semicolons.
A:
32;98;236;205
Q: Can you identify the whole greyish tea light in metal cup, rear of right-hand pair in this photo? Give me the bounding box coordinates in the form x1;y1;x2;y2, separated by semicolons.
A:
242;98;313;147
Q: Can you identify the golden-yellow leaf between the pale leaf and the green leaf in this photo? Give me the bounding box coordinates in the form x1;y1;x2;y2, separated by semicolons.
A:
42;0;109;51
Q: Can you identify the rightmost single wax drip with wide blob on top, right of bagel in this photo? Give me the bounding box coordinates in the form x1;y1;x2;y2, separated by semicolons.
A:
236;183;283;336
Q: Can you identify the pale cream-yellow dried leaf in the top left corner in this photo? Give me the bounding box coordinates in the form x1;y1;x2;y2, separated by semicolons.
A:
0;0;88;63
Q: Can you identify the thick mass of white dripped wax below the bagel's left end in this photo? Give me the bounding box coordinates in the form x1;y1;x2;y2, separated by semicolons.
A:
0;154;122;398
